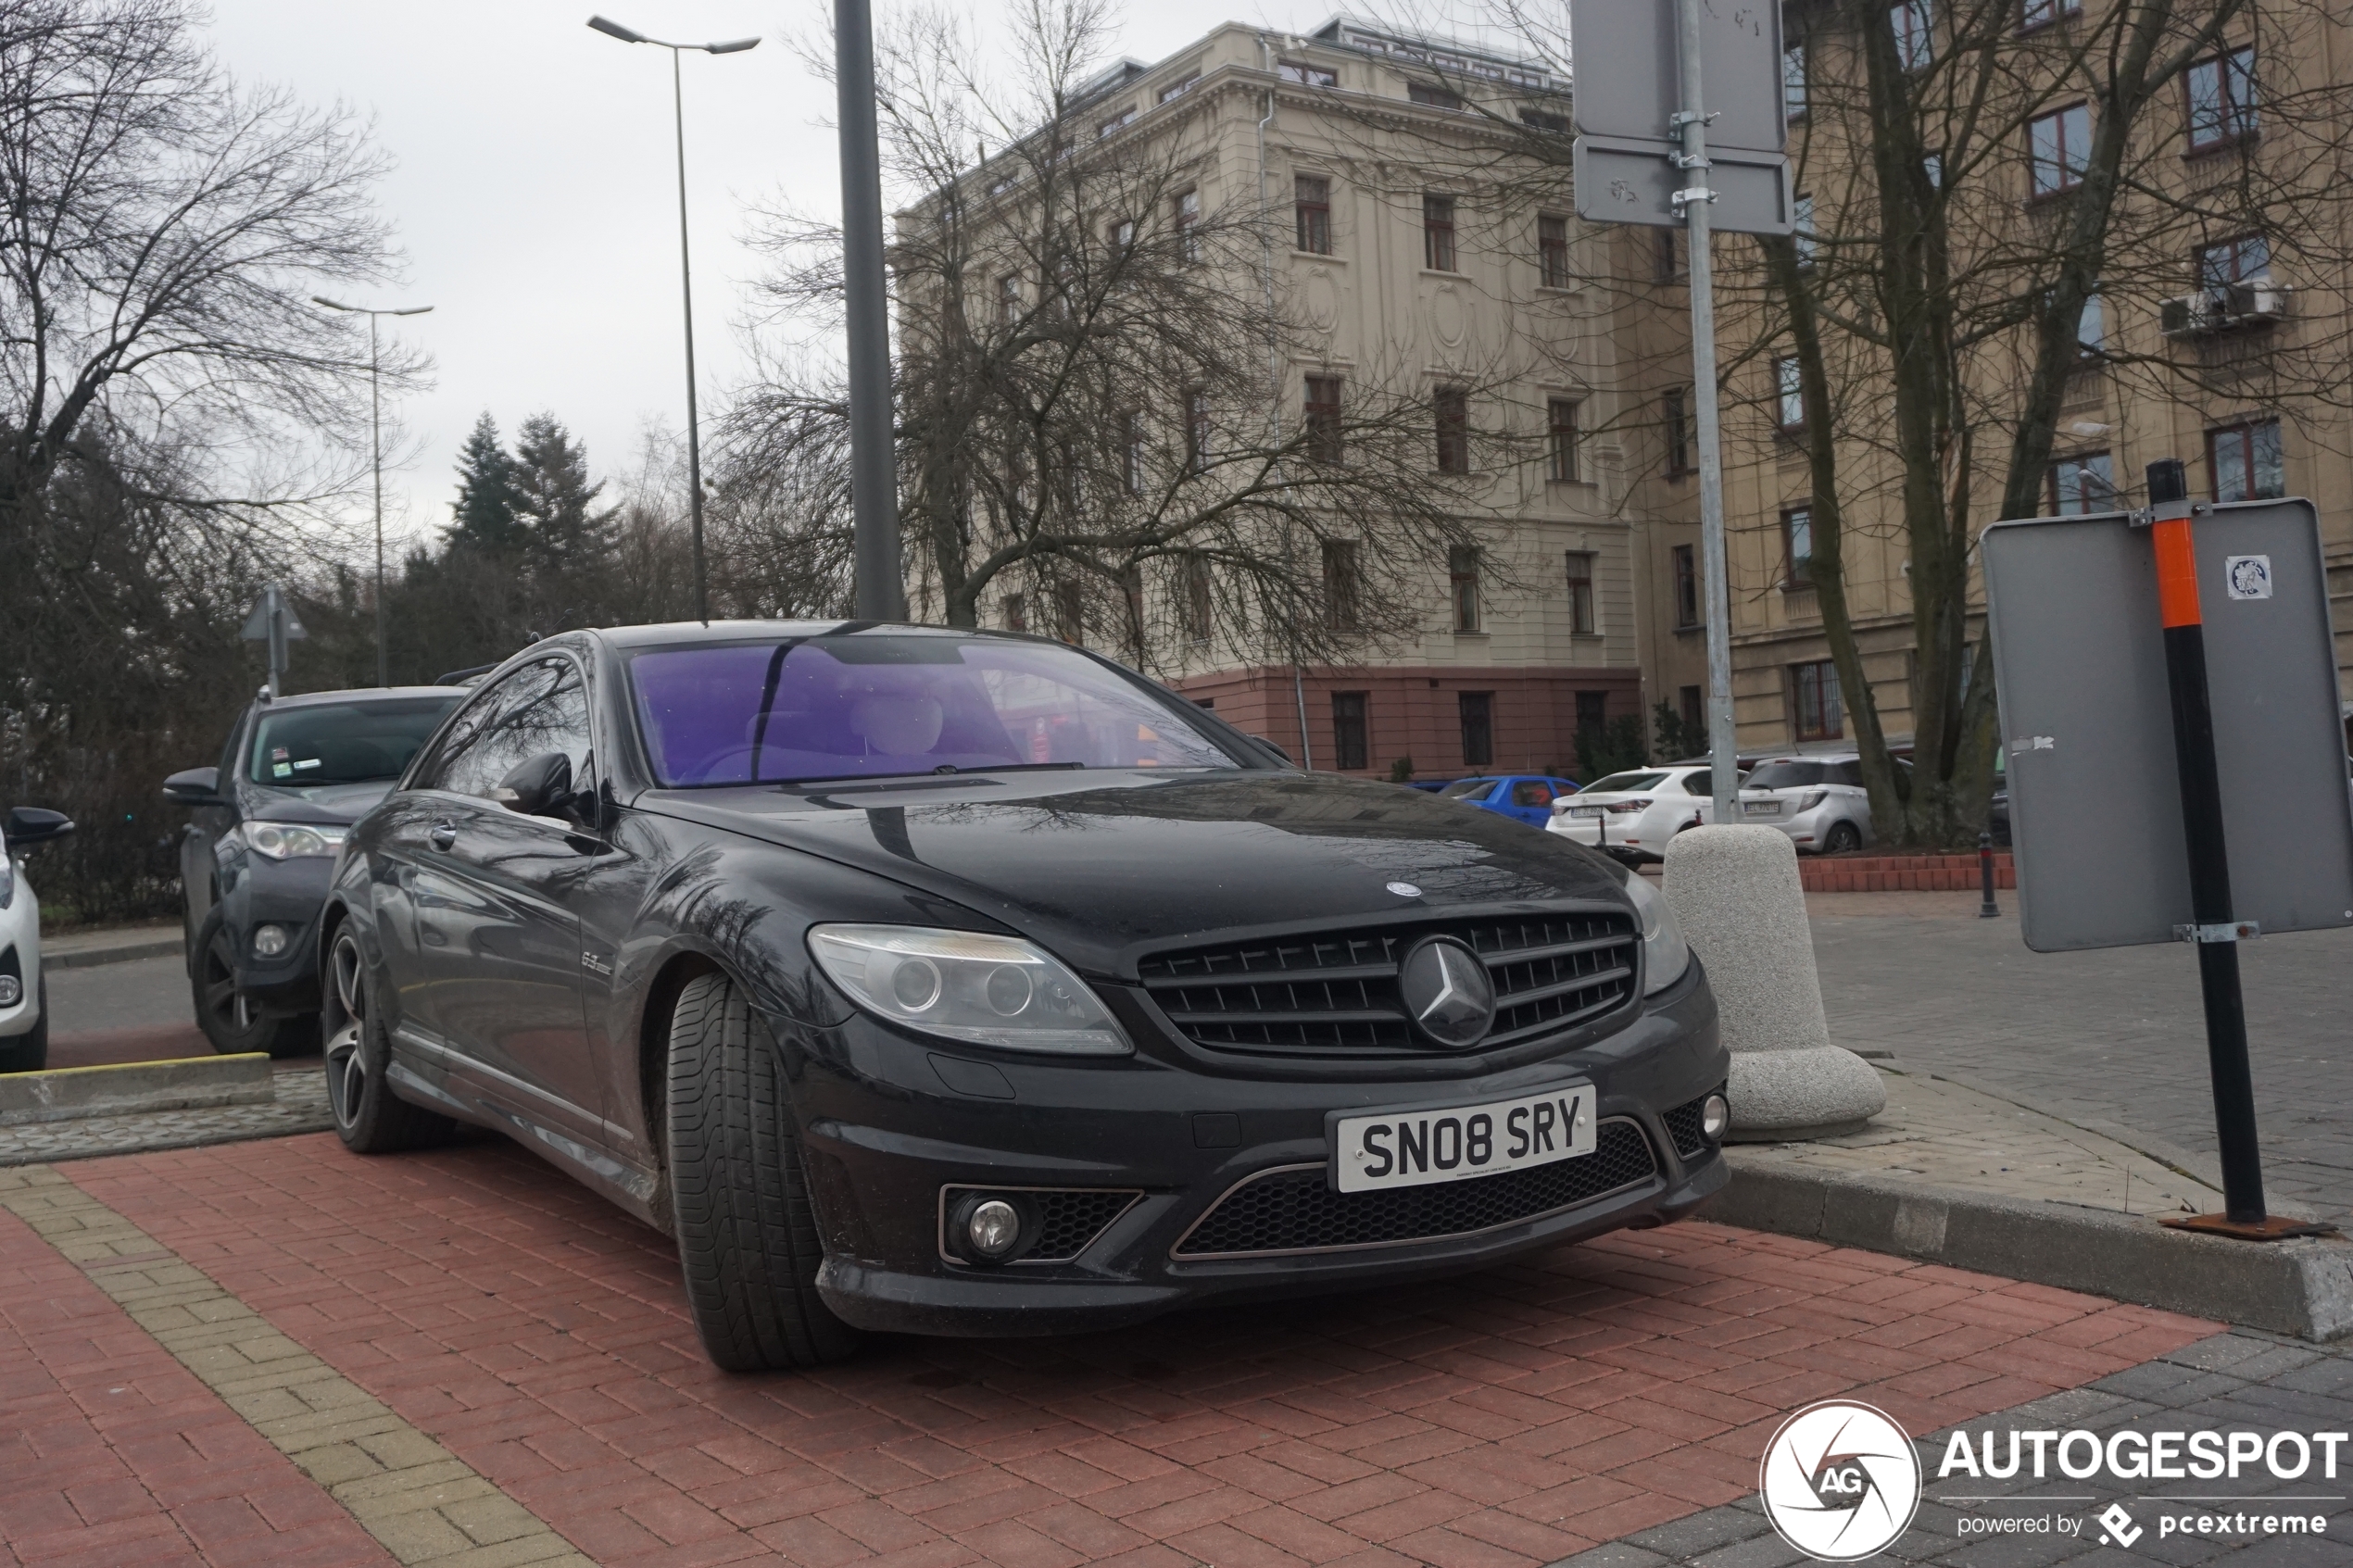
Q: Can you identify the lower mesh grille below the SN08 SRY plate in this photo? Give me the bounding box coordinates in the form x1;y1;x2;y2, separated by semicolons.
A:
1174;1117;1659;1260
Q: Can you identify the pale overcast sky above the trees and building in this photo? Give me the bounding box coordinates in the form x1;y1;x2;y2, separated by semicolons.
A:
214;0;1337;552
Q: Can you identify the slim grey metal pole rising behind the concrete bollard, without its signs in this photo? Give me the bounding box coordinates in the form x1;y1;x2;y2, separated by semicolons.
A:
1675;0;1742;822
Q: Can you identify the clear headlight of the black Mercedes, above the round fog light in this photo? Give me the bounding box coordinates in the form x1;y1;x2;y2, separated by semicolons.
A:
810;926;1134;1056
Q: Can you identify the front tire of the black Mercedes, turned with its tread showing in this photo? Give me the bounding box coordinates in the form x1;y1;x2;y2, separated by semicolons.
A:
668;973;859;1373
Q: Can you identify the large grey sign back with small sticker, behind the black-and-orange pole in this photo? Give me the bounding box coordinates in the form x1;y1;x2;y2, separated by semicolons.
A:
1982;501;2353;952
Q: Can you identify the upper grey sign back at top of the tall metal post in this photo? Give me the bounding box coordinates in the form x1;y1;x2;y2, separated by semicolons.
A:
1569;0;1788;152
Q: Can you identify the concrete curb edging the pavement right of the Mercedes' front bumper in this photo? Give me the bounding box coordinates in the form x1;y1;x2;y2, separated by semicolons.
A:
1701;1152;2353;1342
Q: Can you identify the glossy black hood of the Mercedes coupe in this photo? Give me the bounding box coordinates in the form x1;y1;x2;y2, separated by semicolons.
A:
633;771;1629;973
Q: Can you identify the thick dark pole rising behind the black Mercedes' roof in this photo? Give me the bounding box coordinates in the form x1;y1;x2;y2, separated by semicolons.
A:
833;0;906;621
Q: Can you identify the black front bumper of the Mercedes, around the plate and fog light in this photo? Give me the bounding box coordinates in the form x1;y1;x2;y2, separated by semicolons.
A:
779;964;1727;1336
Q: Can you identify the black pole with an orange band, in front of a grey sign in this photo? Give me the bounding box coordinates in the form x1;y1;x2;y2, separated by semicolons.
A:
2148;458;2263;1227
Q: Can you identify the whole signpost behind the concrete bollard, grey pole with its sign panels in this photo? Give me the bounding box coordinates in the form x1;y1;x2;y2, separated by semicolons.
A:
1569;0;1795;822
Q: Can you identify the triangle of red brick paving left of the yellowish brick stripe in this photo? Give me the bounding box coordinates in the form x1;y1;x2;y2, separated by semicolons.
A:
0;1210;393;1568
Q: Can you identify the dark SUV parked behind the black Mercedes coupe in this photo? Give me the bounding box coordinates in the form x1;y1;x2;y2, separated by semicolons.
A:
162;686;466;1056
